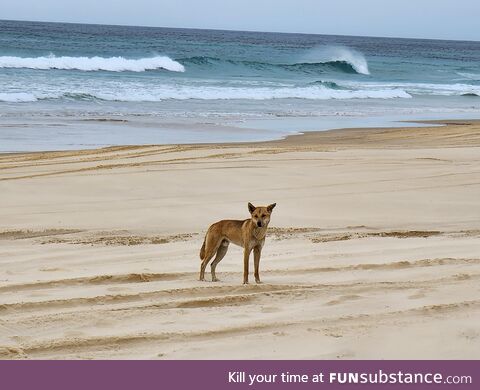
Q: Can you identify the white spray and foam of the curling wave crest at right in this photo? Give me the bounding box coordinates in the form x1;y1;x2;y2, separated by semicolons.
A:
302;46;370;75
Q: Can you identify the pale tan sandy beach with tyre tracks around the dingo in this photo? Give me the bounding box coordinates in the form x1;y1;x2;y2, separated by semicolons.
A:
0;122;480;359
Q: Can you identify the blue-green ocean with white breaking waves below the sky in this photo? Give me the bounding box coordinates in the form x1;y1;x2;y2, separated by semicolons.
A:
0;21;480;151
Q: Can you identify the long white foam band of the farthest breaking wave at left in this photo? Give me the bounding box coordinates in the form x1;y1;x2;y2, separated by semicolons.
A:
0;55;185;72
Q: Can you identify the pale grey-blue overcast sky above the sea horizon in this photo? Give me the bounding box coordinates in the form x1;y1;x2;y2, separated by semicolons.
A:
0;0;480;41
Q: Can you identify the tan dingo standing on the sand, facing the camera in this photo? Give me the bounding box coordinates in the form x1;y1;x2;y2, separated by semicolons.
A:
200;203;276;284
